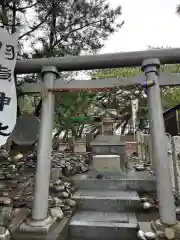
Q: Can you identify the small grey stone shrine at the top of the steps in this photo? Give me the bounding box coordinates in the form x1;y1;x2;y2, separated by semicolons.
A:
91;110;125;173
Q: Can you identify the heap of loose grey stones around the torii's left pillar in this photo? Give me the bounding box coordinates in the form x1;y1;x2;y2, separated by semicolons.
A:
0;149;91;233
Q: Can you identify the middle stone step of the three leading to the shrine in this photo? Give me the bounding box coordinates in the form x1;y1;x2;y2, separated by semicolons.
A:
72;190;140;212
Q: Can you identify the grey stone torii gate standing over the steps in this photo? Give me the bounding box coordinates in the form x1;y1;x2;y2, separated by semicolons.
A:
15;49;180;238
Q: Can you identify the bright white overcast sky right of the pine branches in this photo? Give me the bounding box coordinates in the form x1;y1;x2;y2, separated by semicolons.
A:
100;0;180;53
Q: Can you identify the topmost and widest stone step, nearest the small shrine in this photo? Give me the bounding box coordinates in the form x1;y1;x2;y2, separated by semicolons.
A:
74;178;156;192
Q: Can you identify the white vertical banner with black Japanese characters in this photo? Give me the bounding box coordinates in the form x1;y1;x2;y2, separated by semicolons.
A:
0;28;19;146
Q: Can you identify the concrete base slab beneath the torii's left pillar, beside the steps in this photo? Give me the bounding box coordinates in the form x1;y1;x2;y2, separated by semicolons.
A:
12;217;69;240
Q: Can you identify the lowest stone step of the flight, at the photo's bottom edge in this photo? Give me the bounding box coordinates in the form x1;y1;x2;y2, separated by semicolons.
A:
69;211;138;240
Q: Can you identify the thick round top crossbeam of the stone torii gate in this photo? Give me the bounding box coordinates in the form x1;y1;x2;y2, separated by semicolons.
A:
15;48;180;74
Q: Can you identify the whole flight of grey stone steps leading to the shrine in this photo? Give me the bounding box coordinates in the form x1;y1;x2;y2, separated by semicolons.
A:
68;174;155;240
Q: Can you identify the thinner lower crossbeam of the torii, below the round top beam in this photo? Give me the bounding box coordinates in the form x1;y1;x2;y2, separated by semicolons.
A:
20;73;180;93
